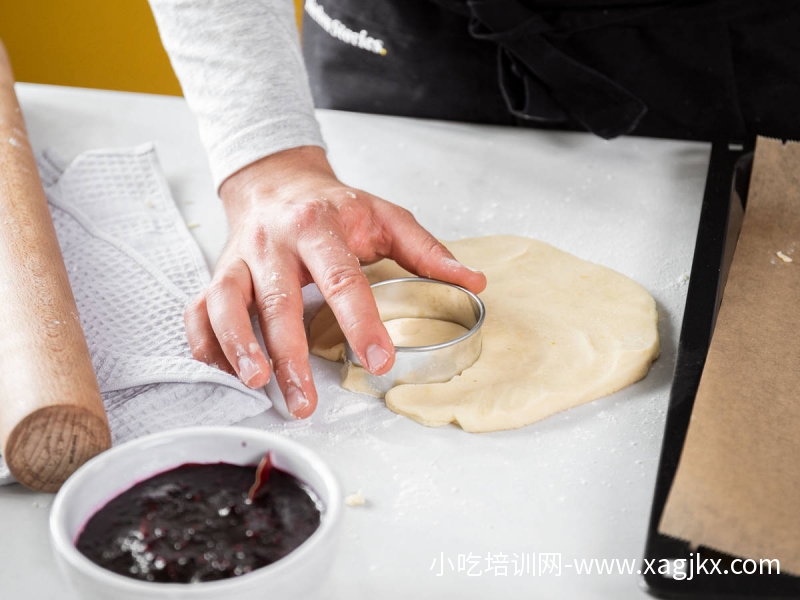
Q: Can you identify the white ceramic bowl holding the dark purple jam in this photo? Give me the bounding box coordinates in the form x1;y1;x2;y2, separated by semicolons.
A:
50;427;342;600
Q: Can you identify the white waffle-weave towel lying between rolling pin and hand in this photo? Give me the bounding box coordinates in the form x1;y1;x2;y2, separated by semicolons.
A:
0;144;271;485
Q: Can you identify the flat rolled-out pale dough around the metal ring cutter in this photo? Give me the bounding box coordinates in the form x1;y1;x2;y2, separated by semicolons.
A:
309;236;659;432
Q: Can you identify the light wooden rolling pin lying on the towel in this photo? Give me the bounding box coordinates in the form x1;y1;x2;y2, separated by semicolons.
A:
0;43;111;492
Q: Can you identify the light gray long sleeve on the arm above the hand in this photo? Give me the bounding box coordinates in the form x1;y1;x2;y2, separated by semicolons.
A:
150;0;324;189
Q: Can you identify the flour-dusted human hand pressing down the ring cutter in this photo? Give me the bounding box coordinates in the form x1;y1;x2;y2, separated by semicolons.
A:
184;146;486;418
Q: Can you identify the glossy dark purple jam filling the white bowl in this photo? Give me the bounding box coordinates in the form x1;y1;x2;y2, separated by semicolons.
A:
76;463;320;583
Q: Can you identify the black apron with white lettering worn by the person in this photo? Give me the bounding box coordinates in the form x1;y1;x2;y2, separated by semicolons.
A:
303;0;800;140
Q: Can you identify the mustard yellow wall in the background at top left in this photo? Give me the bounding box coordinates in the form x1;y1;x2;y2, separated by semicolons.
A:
0;0;302;95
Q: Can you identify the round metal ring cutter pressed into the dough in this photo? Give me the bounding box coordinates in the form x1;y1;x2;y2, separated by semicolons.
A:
345;277;486;394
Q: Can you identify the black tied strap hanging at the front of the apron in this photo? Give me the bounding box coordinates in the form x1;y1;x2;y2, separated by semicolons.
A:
467;0;647;139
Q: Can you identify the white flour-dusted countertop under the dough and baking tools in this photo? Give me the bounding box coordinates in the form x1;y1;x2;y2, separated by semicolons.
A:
0;84;709;600
